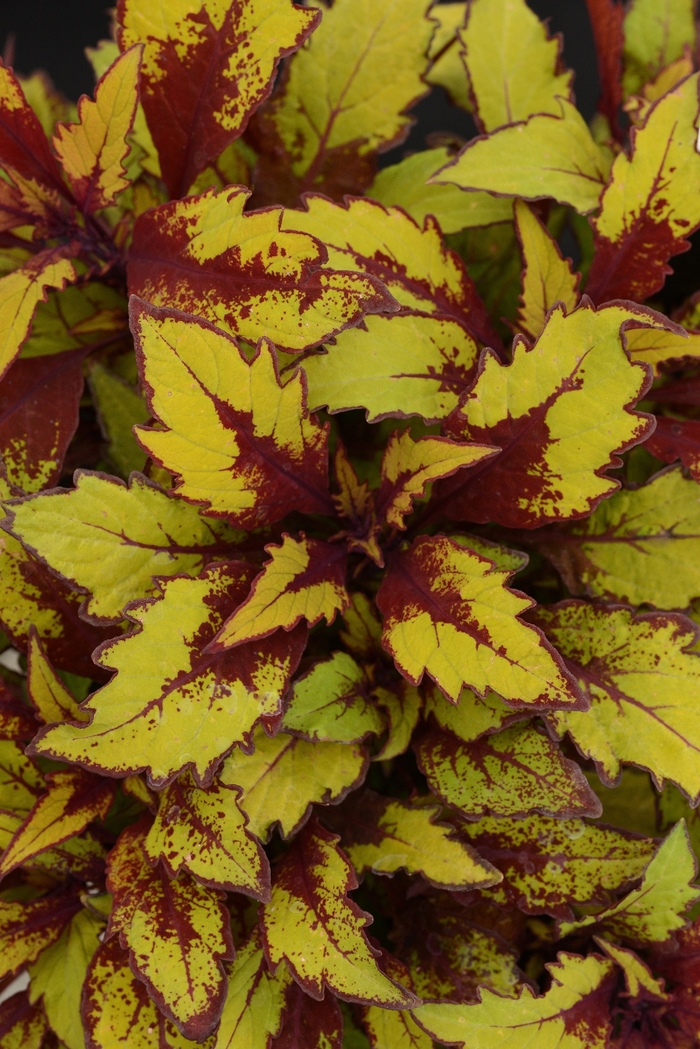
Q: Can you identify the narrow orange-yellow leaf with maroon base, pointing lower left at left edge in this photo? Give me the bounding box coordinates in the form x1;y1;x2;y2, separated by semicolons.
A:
0;769;114;878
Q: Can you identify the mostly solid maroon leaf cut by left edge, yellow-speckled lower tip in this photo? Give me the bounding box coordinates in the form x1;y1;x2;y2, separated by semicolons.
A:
0;350;83;492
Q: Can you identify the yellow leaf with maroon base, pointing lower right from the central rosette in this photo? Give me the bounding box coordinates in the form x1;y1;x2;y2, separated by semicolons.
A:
377;536;581;707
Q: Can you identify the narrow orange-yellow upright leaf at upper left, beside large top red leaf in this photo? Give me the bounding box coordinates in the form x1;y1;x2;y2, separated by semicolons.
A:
54;46;143;213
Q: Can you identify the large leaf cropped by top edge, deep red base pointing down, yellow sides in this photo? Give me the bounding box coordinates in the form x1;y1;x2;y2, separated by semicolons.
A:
118;0;319;197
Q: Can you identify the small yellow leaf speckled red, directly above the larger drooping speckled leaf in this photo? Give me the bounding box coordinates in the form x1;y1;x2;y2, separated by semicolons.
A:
144;773;270;900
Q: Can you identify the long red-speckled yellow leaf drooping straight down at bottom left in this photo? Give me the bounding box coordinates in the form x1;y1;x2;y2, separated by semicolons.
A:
107;825;233;1041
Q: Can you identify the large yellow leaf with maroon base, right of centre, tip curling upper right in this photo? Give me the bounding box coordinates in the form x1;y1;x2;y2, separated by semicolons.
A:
436;299;664;528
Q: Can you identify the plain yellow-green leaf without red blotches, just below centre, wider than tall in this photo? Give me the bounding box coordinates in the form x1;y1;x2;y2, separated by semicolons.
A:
219;728;367;841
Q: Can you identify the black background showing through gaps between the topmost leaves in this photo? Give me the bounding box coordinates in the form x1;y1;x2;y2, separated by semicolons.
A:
0;0;598;151
